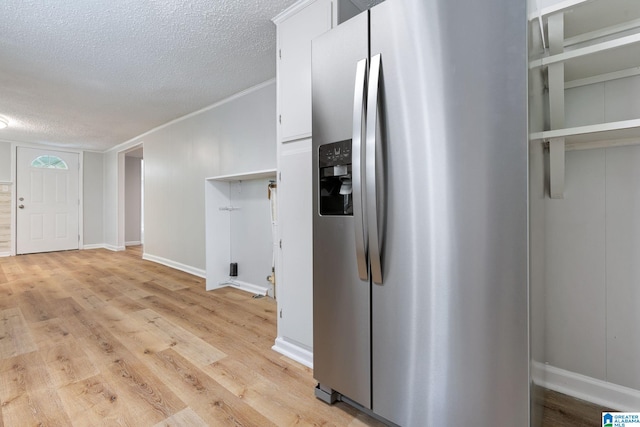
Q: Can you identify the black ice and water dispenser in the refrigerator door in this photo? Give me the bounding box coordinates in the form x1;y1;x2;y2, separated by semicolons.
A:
318;139;353;215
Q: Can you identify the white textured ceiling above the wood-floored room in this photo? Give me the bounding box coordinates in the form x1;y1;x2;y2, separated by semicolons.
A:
0;0;295;151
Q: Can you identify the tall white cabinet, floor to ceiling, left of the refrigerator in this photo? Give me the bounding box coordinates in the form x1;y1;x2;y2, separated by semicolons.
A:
273;0;359;366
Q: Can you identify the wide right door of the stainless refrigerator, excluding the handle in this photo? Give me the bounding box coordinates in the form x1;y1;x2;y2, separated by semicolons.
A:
371;0;529;427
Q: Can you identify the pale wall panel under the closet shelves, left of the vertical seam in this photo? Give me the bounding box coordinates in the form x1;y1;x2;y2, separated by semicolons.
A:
545;150;606;380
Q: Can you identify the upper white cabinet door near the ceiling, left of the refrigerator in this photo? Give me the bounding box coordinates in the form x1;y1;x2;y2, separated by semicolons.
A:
278;0;332;141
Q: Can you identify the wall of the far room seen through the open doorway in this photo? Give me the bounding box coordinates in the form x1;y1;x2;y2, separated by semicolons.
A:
124;156;142;245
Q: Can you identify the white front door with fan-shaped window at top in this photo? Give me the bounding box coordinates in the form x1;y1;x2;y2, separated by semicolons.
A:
16;147;80;254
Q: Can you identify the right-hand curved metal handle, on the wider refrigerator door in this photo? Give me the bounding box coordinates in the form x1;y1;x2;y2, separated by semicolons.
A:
365;54;382;284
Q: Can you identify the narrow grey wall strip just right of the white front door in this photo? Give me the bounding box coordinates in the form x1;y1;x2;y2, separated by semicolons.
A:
82;151;104;246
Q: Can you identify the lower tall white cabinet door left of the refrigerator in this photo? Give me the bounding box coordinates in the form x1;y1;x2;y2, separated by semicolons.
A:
277;140;313;349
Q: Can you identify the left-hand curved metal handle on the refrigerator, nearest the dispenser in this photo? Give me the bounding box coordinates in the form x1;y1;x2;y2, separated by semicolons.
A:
351;59;369;280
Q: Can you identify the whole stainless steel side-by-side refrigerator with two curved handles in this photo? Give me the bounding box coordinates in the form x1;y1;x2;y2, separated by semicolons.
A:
312;0;529;427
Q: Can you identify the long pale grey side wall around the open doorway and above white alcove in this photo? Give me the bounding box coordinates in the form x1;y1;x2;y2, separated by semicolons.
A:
104;82;276;270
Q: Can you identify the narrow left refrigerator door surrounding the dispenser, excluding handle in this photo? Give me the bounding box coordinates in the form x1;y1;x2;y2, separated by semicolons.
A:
311;14;371;407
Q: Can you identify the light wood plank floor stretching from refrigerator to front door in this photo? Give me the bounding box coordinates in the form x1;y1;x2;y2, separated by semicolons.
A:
0;248;379;427
